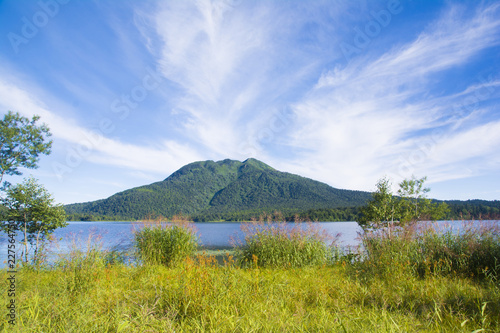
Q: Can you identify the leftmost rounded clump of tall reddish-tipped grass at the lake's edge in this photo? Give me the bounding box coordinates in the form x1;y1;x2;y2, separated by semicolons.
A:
134;222;198;266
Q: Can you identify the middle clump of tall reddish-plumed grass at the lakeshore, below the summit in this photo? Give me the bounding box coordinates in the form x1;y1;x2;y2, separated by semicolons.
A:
235;222;333;268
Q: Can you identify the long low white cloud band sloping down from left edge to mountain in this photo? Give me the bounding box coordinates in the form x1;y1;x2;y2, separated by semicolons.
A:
0;81;203;179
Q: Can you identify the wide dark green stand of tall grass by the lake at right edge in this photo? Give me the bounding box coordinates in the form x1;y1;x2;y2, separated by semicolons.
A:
360;223;500;280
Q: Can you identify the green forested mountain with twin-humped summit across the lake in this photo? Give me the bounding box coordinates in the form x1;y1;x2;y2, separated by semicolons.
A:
65;158;371;221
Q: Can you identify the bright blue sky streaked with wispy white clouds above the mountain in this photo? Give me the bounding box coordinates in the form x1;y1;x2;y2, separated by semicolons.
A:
0;0;500;204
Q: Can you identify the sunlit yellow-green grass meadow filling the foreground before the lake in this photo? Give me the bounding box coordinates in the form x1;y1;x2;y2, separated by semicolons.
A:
0;219;500;332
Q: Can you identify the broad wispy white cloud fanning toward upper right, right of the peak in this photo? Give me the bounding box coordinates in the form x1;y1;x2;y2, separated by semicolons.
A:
284;5;500;189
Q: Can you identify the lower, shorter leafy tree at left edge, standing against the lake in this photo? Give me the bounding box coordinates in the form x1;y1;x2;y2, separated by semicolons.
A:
1;177;67;262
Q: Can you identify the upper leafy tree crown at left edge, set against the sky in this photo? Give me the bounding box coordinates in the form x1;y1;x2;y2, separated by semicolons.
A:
0;111;52;185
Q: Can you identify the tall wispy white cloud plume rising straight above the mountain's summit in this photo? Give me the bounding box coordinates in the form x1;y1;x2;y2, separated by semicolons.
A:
147;0;344;157
